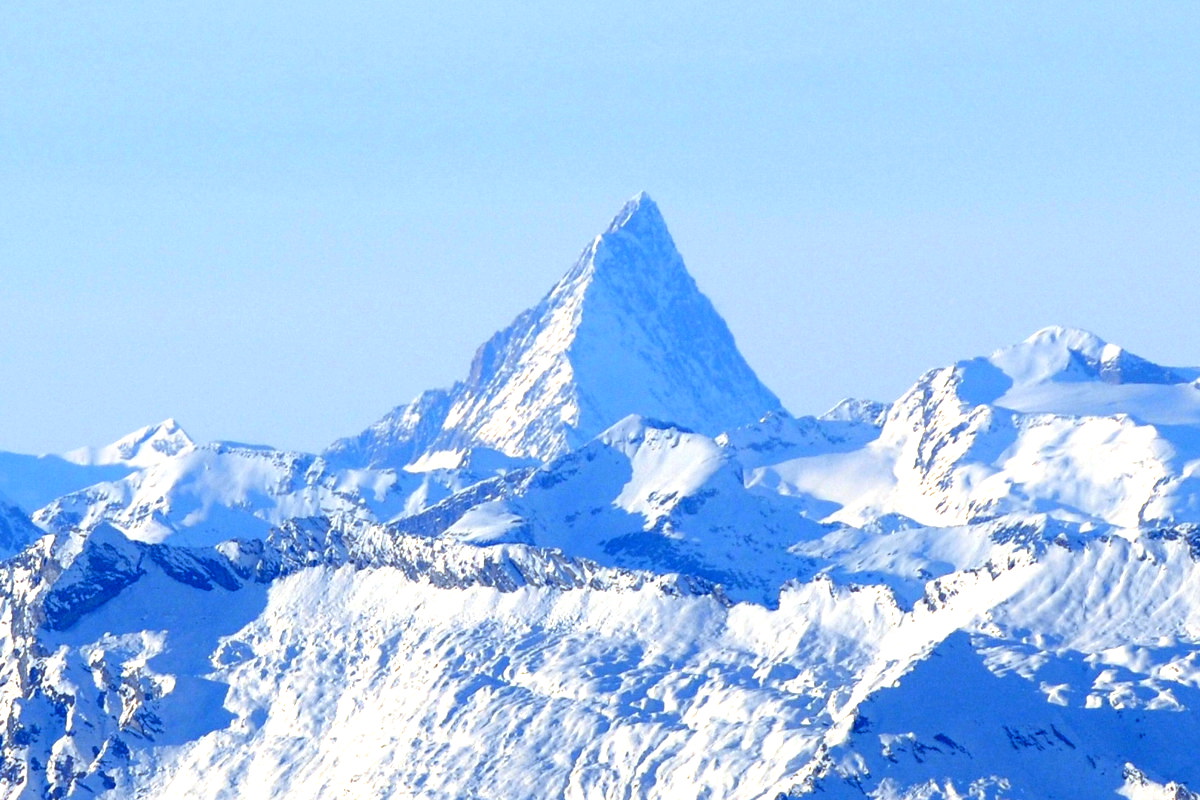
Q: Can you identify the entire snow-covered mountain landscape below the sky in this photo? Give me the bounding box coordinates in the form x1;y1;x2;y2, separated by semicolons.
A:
0;194;1200;800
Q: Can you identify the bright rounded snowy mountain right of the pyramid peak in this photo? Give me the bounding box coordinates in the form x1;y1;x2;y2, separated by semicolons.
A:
750;329;1200;527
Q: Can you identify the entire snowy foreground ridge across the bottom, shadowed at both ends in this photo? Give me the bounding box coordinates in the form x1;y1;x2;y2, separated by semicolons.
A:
11;521;1200;800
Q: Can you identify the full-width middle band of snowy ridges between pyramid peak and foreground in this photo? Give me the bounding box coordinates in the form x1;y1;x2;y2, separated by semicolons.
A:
13;314;1200;575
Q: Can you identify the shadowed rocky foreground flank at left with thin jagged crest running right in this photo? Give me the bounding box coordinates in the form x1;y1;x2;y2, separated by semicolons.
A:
0;521;727;796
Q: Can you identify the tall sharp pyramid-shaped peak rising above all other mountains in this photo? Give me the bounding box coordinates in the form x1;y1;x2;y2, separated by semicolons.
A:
326;192;781;468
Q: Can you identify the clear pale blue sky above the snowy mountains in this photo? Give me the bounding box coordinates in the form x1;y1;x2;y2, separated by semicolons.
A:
0;0;1200;452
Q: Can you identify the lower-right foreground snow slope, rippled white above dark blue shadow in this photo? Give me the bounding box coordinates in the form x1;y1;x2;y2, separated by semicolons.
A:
810;527;1200;799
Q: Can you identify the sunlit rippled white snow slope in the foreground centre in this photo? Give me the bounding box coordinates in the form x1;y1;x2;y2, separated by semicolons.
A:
121;571;902;799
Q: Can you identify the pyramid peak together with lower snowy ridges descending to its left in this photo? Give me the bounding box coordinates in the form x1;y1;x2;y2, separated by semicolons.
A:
29;194;782;545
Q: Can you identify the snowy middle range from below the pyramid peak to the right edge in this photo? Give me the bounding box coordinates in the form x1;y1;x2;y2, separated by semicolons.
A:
376;329;1200;604
